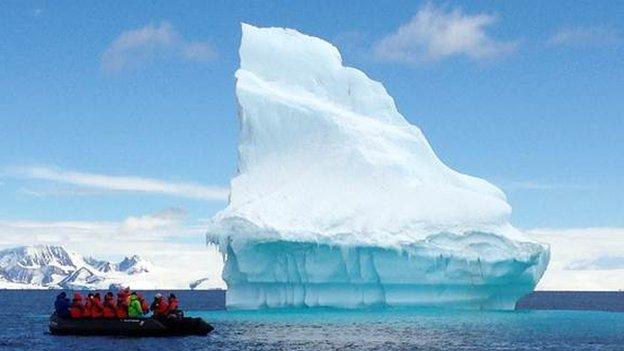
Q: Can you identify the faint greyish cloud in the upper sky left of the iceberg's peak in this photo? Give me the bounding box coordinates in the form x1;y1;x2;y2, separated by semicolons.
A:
101;22;216;72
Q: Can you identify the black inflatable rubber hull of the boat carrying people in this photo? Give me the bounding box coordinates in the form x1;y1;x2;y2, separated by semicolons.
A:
50;314;214;336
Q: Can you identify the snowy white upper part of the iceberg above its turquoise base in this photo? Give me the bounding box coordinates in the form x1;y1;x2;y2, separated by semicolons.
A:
218;24;516;246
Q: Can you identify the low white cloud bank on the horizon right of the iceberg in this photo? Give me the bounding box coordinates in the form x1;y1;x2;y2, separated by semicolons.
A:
527;228;624;290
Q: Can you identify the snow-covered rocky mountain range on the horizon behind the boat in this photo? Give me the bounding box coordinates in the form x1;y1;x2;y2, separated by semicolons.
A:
0;245;214;290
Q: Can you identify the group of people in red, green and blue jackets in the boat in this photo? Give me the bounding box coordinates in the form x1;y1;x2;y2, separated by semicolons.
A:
54;288;182;318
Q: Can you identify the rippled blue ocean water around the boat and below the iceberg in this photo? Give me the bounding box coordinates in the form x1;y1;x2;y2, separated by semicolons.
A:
0;291;624;351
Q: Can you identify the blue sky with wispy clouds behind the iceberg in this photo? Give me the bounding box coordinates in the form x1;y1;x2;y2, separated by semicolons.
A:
0;1;624;245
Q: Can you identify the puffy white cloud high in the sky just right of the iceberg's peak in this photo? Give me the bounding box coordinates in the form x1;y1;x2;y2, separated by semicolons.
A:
374;3;516;63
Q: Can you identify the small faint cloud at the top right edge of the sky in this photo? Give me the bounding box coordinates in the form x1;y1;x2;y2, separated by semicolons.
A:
548;26;622;47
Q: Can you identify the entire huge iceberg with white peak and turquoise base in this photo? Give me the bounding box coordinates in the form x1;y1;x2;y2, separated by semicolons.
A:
206;24;549;309
